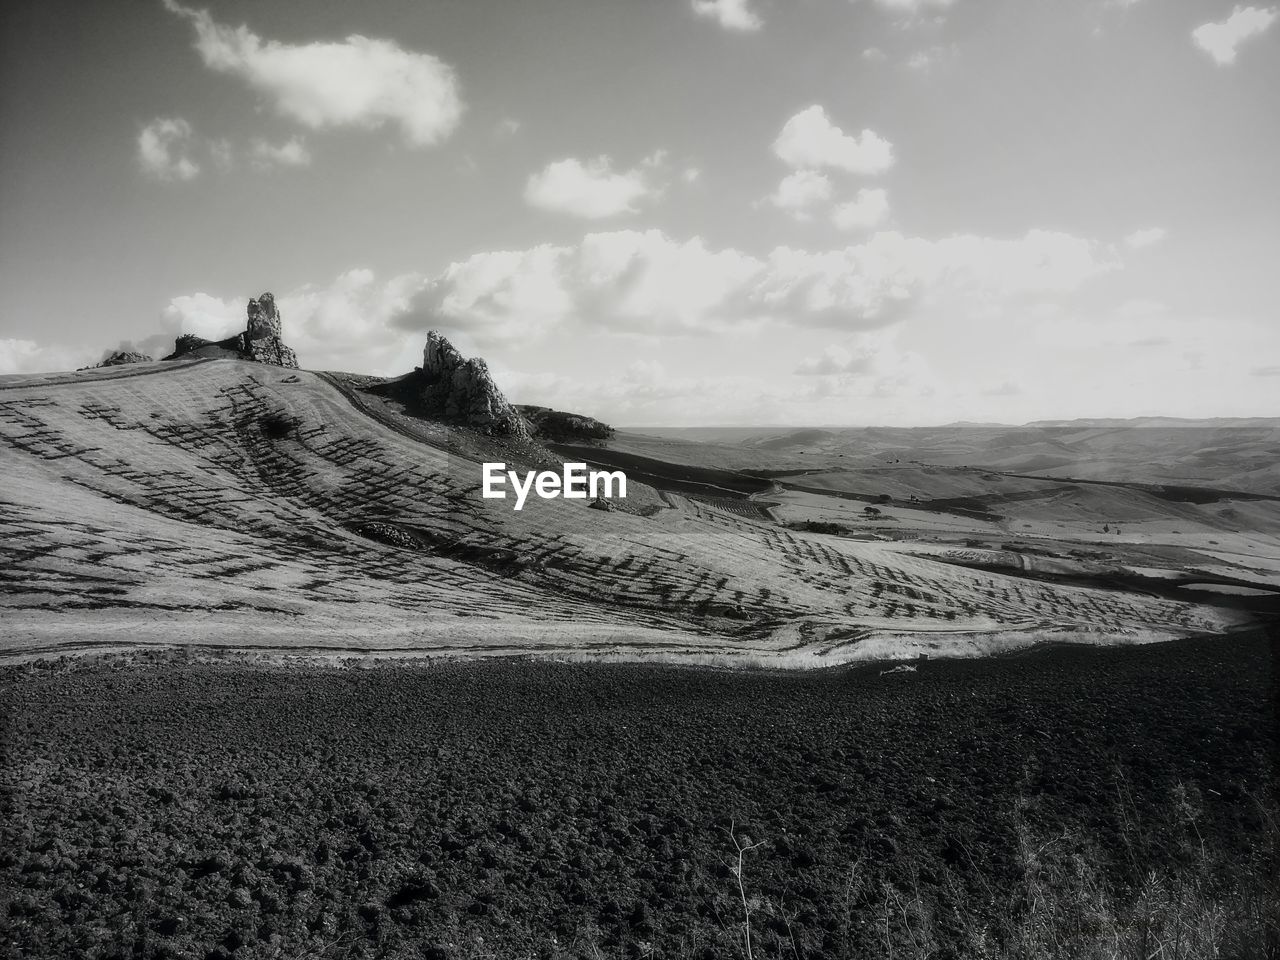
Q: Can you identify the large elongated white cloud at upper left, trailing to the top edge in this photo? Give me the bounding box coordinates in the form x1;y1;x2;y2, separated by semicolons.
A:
164;0;463;146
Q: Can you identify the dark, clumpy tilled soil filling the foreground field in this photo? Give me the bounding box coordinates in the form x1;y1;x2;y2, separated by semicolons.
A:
0;636;1276;957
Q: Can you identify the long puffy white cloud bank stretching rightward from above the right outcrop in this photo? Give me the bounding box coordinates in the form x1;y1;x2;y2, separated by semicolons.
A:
397;230;1119;342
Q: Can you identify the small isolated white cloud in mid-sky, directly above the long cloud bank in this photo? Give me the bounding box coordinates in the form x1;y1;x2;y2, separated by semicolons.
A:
525;154;662;220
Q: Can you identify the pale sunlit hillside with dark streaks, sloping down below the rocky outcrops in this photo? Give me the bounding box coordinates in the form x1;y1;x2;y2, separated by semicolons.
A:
0;360;1244;664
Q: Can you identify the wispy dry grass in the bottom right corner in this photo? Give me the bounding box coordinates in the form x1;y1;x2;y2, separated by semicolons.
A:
854;783;1280;960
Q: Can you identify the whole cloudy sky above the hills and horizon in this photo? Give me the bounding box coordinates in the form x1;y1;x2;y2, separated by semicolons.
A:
0;0;1280;426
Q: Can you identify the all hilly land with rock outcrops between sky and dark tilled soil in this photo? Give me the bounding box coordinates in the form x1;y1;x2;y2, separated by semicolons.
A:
0;316;1280;667
